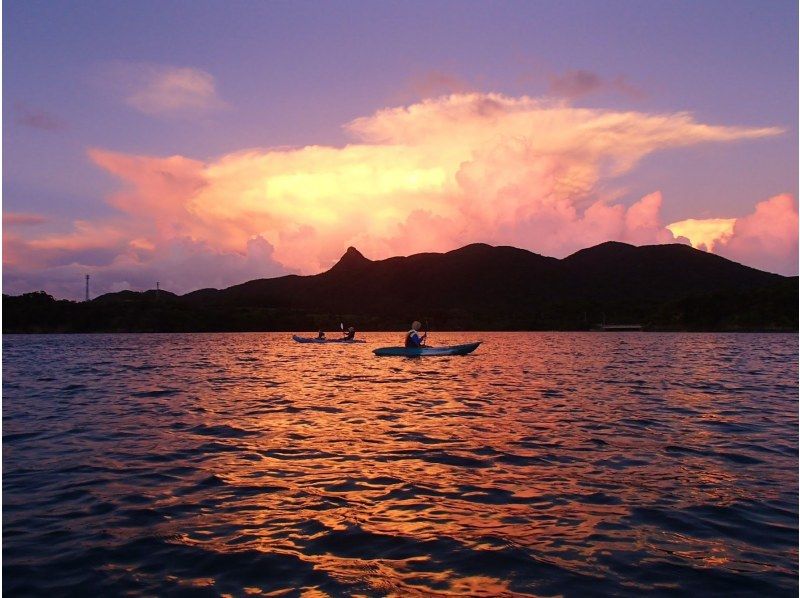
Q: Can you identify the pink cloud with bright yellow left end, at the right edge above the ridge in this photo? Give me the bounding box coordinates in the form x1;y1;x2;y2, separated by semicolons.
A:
668;194;798;275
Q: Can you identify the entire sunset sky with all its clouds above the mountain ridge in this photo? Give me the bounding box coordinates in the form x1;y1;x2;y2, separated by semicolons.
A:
2;0;798;299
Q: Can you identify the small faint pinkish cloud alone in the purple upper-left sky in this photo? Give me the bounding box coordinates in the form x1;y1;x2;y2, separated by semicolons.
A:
101;62;227;117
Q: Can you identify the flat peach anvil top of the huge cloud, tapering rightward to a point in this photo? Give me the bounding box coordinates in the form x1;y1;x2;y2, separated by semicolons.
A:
346;93;783;151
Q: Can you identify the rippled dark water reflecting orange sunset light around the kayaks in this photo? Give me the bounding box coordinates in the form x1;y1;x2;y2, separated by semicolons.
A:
3;333;798;596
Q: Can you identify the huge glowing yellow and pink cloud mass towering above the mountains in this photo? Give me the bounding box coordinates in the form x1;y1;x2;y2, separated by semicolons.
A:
7;93;797;298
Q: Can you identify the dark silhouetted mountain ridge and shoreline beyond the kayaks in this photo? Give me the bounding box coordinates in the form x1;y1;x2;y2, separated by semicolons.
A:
3;243;798;333
